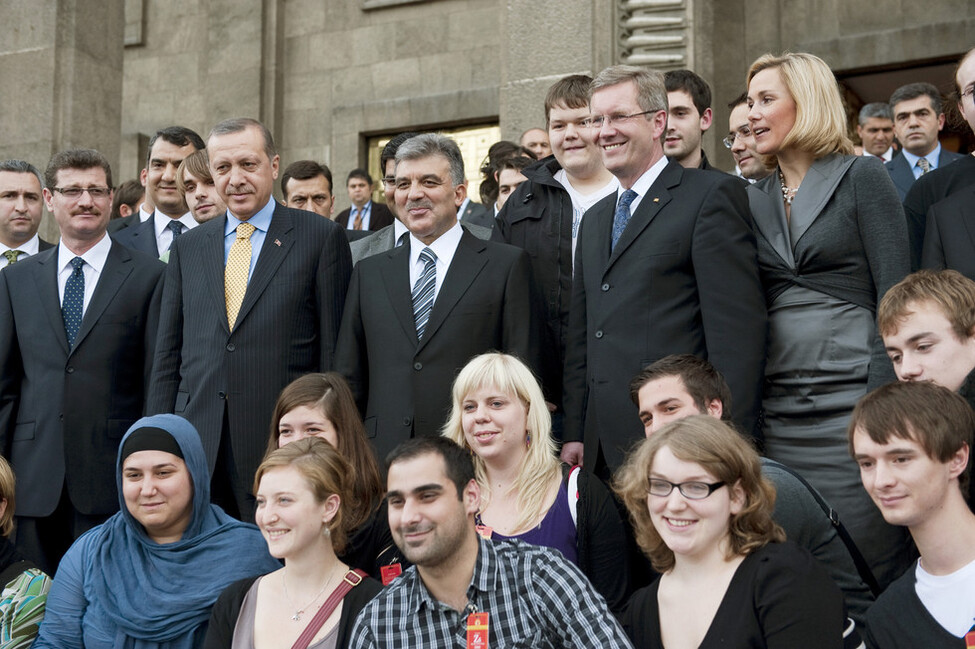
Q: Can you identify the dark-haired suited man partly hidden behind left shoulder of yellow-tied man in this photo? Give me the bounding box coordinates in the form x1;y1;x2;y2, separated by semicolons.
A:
113;126;205;257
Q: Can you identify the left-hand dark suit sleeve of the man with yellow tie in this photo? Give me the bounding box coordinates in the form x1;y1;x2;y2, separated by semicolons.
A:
145;239;183;415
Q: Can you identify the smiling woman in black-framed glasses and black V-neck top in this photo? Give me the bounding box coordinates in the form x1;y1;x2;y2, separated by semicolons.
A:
616;415;846;649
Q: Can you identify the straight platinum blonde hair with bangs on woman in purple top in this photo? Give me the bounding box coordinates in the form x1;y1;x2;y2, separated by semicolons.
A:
443;353;561;530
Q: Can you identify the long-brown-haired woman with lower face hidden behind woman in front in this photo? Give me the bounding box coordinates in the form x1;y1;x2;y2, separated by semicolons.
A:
267;372;398;583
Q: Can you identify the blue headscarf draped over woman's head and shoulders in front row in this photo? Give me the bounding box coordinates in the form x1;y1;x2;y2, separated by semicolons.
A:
85;415;281;649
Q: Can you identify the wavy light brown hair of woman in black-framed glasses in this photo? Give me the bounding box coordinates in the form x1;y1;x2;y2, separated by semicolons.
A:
613;415;785;572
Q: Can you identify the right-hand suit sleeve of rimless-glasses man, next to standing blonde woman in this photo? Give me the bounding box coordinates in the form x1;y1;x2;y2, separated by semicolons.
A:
692;176;767;436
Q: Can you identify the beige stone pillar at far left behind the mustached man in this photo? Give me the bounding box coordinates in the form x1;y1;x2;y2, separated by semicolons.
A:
0;0;125;240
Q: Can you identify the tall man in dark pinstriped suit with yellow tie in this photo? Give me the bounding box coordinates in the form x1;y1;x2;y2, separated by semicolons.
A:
149;118;351;519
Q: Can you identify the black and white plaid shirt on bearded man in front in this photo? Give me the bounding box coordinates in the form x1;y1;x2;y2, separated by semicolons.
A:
349;537;632;649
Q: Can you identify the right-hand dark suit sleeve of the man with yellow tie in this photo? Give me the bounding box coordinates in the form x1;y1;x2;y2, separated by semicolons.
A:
315;228;352;372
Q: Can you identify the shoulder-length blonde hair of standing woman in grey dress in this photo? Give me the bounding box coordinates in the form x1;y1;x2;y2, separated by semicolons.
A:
748;52;853;167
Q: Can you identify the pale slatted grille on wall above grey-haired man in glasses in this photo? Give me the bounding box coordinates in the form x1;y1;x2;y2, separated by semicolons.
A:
617;0;693;69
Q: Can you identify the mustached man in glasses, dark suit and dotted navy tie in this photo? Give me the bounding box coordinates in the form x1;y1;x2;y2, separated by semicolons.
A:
0;149;165;571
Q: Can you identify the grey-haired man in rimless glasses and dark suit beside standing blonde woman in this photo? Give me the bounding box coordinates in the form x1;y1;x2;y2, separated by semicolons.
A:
562;66;766;476
